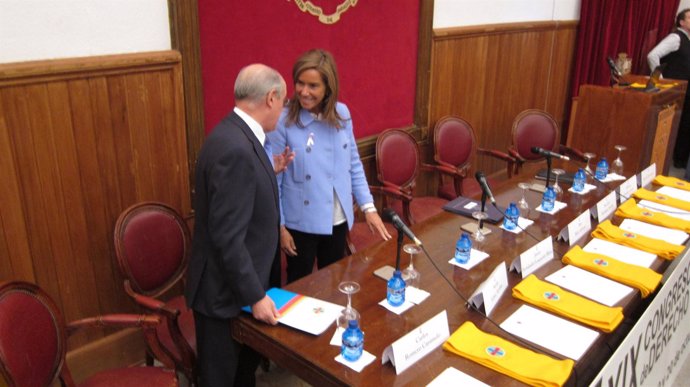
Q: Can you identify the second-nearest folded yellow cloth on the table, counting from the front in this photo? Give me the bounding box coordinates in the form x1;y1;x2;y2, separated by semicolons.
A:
513;274;623;333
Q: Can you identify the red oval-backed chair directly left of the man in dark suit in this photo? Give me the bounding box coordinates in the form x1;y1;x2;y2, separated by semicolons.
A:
114;202;196;383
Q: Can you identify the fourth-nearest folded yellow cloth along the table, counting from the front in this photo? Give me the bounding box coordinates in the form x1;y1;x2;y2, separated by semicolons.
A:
592;220;685;260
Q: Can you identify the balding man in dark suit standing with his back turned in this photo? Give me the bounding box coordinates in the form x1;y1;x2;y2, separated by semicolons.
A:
185;64;286;386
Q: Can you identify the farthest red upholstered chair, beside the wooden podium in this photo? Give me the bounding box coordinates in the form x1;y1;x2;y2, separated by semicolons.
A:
508;109;586;174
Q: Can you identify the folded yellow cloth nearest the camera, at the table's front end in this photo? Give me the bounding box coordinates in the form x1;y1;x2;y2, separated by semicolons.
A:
443;321;575;386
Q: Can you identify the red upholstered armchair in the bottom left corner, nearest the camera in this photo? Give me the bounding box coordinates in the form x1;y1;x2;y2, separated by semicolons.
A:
0;281;178;387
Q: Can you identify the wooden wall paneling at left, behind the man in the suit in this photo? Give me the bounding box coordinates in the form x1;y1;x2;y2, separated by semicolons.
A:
0;51;191;358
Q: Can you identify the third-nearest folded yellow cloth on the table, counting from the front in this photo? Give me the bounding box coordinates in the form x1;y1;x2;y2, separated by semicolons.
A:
563;246;661;298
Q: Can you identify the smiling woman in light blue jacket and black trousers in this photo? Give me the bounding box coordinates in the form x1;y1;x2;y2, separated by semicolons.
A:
269;49;391;282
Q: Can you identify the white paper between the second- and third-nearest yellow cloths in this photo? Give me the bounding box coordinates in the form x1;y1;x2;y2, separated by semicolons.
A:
545;265;633;306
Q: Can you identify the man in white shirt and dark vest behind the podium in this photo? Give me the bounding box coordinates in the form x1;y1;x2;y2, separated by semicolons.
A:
647;8;690;170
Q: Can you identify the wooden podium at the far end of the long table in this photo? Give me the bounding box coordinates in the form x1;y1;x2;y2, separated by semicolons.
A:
566;75;687;174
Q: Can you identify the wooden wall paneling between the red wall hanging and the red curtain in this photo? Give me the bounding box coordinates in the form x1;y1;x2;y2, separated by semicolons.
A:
428;22;576;177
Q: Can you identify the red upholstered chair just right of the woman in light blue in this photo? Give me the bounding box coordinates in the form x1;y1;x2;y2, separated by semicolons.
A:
370;129;448;224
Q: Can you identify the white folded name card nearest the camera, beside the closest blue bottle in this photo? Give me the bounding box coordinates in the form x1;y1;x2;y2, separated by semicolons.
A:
381;310;450;375
